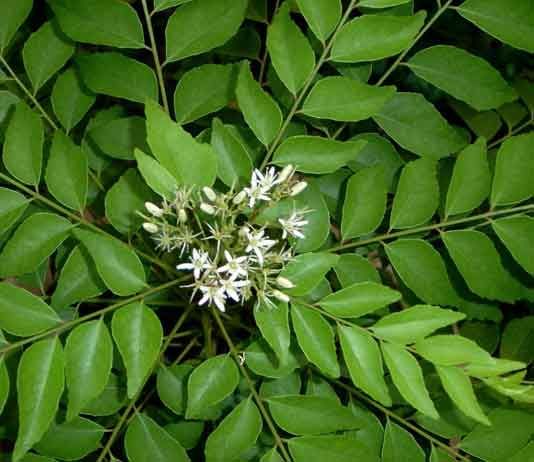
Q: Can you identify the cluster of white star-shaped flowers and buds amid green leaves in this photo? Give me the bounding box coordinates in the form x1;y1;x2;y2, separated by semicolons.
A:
140;165;309;312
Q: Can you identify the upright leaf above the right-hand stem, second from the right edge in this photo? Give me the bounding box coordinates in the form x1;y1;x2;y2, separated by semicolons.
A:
445;138;491;216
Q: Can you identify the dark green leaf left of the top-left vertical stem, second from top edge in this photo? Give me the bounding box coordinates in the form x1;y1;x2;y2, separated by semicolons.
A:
76;52;158;103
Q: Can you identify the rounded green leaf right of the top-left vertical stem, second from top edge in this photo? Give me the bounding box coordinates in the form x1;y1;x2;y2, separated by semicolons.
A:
174;64;236;124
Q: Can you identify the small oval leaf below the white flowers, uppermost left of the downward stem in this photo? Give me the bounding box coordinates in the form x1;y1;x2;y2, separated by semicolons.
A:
185;355;239;419
